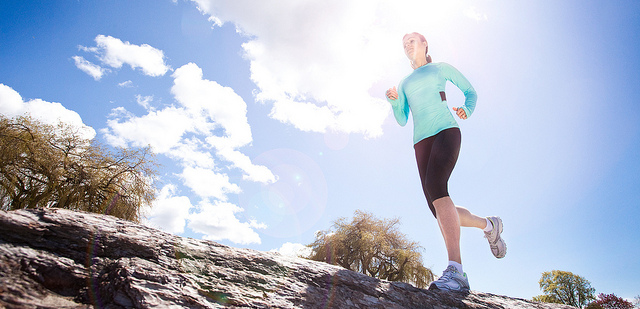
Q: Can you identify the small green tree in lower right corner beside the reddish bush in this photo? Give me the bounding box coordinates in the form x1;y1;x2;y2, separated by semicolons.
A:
533;270;595;308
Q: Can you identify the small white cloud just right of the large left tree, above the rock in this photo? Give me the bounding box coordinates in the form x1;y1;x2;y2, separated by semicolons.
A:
145;185;192;234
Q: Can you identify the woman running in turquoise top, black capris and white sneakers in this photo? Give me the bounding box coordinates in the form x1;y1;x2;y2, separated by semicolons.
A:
386;32;507;291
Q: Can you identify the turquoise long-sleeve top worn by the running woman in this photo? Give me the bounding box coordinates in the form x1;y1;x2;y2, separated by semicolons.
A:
387;62;478;144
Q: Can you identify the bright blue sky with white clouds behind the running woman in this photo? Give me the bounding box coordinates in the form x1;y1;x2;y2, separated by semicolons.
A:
0;0;640;298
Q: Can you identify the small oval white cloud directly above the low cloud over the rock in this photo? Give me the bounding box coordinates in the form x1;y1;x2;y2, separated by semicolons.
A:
180;167;241;201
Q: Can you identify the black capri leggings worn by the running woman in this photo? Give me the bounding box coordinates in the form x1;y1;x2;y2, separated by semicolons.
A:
413;128;462;218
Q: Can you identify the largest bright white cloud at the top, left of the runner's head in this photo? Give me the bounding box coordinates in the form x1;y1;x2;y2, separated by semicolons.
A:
189;0;389;136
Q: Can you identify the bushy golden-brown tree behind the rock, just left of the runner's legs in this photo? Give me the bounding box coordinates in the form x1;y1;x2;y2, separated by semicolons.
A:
308;210;434;288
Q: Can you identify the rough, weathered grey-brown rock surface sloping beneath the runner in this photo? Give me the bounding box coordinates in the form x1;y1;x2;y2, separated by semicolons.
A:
0;209;572;308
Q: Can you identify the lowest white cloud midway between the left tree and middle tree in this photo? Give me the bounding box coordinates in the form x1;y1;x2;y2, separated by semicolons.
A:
188;202;267;244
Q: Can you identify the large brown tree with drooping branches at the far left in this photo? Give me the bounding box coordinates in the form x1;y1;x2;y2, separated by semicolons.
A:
0;115;156;222
